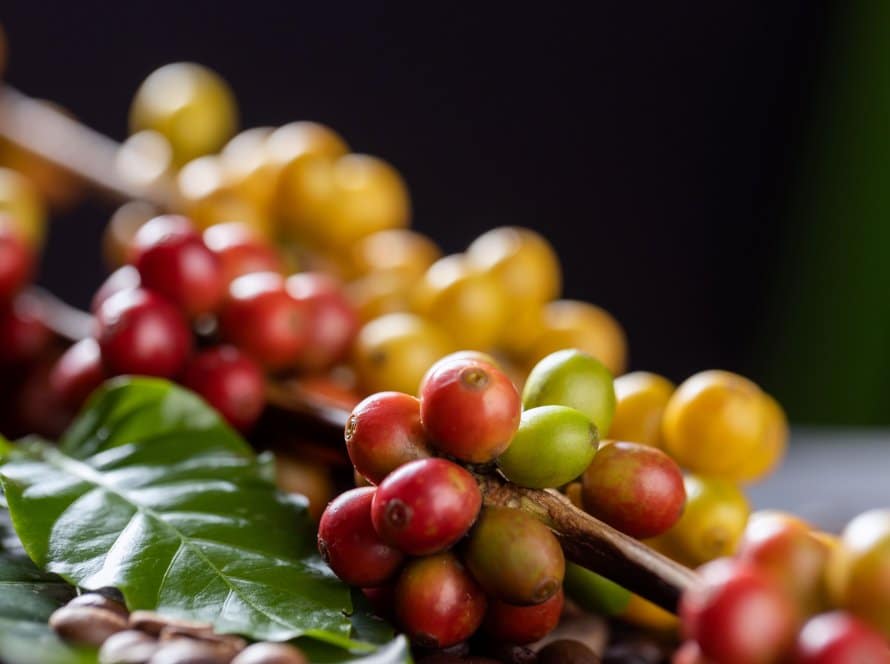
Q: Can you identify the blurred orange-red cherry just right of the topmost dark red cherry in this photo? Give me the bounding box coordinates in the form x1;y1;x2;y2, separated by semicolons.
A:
204;221;284;285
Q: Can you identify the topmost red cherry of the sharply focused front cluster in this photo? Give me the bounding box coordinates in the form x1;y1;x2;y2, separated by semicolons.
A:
420;357;522;463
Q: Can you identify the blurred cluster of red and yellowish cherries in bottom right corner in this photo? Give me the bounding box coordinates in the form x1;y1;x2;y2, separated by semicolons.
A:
674;510;890;664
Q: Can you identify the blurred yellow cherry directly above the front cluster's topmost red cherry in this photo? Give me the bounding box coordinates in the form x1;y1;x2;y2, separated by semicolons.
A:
413;254;509;350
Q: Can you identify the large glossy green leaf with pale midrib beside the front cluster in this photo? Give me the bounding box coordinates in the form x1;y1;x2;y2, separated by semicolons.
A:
0;378;373;652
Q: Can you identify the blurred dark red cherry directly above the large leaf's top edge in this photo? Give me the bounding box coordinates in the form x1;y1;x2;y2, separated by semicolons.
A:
96;288;192;378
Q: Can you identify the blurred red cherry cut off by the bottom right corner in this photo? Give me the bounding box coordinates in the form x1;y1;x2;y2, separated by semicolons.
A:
794;611;890;664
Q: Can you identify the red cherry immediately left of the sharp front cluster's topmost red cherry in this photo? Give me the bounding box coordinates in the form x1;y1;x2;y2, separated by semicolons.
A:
345;392;430;484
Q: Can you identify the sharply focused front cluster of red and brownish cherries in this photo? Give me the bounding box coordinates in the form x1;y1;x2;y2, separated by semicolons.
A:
318;352;576;648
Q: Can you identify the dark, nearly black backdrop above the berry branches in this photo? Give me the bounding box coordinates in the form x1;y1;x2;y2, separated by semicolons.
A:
0;0;831;394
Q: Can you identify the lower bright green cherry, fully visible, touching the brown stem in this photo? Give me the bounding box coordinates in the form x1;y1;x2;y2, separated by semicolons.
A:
498;406;599;489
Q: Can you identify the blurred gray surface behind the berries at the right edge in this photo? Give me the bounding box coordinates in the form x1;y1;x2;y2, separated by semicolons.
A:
747;429;890;532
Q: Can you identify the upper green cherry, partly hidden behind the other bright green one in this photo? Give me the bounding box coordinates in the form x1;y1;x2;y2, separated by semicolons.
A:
522;349;615;435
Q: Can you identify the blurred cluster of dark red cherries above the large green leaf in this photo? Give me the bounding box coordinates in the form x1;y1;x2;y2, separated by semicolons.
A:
50;210;357;431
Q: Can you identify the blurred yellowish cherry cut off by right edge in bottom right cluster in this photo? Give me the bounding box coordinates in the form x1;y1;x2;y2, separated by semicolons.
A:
828;509;890;639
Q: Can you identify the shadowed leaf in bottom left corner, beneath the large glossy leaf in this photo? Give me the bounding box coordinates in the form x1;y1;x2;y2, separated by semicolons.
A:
0;511;96;664
